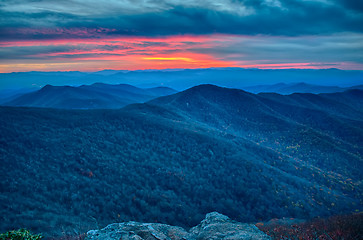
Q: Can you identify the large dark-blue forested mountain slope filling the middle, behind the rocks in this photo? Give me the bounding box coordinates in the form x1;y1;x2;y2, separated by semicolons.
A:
0;85;363;236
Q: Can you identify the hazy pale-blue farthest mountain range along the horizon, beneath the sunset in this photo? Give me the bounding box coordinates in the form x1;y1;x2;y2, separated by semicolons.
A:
0;68;363;91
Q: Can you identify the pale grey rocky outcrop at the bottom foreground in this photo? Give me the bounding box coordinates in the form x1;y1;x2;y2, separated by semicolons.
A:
86;212;270;240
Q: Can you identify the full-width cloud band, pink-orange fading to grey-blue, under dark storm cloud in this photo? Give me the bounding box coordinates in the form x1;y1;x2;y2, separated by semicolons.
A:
0;34;363;70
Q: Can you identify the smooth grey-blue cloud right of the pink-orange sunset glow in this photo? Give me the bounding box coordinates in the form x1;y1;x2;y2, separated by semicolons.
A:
186;34;363;64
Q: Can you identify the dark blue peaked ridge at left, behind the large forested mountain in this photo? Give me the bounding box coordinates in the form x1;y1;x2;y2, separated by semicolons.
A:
3;83;176;109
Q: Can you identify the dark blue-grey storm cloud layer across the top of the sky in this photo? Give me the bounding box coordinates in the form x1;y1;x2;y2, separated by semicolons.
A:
0;0;363;40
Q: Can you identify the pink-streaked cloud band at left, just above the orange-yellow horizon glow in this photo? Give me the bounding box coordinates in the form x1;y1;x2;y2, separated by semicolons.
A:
0;36;222;61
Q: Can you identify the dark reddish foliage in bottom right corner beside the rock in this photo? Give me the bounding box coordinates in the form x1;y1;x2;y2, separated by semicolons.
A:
256;213;363;240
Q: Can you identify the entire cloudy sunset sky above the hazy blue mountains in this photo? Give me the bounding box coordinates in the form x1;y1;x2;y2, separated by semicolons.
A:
0;0;363;73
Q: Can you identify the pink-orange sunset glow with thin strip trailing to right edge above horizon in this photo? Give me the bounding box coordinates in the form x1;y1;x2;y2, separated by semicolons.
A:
0;34;361;73
